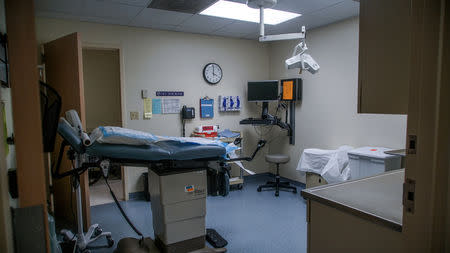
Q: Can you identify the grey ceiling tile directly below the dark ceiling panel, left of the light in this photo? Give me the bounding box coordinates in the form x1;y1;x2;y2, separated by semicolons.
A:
130;8;192;27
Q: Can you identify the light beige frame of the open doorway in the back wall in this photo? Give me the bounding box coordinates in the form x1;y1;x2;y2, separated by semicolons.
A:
81;41;129;200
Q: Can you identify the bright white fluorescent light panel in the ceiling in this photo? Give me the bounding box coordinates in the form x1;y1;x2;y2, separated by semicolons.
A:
200;0;301;25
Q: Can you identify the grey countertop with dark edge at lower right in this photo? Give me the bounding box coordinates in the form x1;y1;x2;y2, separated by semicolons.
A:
301;169;405;231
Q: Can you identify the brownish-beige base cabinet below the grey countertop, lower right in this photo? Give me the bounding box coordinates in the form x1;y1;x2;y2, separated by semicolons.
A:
307;200;403;253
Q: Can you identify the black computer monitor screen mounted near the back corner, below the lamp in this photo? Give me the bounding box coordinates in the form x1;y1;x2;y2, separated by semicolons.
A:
247;80;278;102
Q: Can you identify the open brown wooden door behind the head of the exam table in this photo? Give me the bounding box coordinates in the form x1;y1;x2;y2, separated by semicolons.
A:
44;33;90;229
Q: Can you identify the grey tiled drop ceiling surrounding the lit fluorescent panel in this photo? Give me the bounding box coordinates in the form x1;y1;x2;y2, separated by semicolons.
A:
35;0;359;39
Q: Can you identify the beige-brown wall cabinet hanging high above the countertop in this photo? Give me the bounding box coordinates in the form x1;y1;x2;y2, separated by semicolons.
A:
358;0;411;114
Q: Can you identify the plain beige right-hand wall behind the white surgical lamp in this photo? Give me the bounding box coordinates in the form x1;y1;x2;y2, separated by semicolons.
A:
270;18;406;182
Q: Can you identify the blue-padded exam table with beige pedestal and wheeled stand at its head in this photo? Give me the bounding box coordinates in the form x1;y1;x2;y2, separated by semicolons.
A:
54;110;265;253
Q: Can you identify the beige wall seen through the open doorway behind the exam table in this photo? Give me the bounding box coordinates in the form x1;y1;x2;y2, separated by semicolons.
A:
83;49;122;131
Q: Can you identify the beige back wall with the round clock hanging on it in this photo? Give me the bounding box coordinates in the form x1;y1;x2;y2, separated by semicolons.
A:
36;18;269;192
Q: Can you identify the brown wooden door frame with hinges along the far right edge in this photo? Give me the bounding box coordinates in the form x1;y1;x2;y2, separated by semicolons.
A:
403;0;450;253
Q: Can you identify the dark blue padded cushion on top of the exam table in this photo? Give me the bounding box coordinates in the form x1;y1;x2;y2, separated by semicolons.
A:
86;141;226;161
